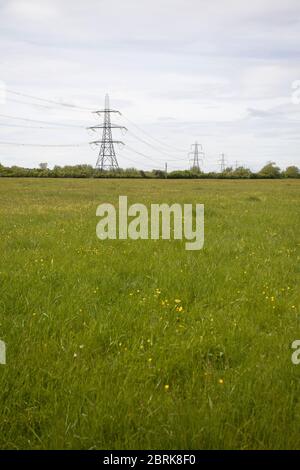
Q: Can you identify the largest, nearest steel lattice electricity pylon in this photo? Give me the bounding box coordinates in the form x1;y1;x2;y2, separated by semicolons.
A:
88;95;127;171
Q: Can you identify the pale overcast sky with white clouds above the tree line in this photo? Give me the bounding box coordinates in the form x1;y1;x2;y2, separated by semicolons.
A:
0;0;300;170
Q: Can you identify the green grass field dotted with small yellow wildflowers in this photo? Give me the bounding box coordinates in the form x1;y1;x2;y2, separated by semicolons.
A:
0;179;300;449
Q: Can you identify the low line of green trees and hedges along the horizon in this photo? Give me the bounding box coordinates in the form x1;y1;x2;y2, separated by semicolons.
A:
0;162;300;179
